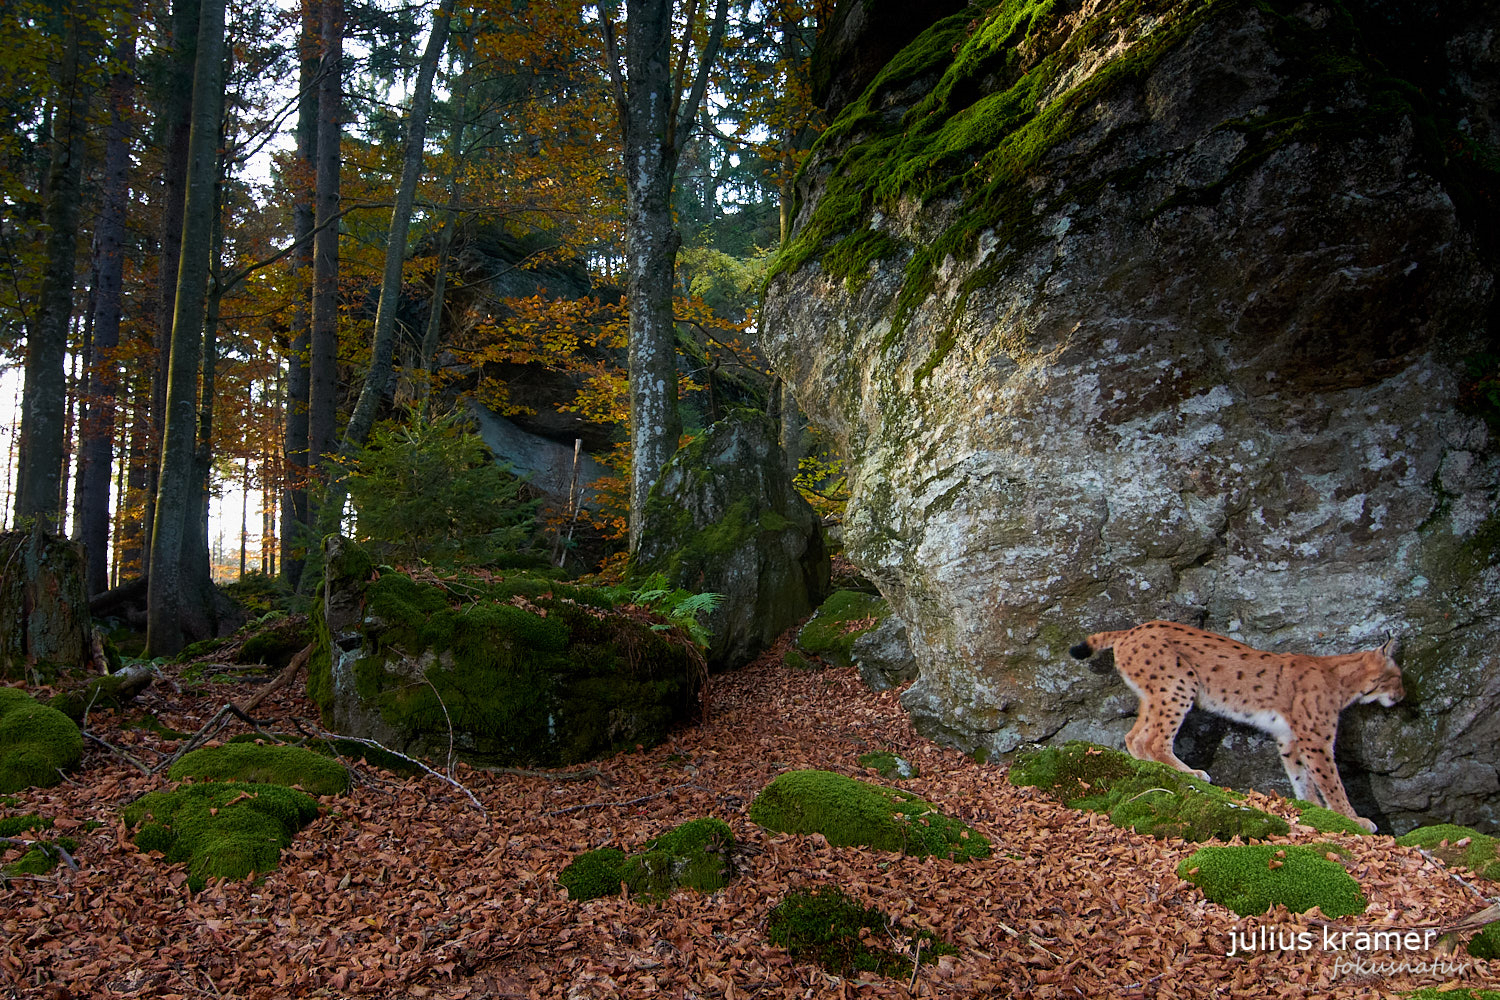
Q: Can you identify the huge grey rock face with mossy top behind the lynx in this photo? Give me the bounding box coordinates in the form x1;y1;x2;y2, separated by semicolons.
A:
762;0;1500;831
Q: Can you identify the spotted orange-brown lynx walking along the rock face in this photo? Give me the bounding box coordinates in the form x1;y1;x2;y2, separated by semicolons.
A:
1068;621;1406;832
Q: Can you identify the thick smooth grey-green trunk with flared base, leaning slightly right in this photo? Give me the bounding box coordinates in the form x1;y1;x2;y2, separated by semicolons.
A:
146;0;224;657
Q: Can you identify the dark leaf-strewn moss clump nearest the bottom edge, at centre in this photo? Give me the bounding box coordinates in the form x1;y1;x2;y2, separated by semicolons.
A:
767;886;957;976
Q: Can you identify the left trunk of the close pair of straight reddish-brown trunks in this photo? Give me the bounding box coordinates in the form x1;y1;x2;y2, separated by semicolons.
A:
281;0;320;589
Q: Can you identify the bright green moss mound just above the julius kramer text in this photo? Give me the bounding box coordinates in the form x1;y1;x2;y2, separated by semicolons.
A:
1178;844;1368;918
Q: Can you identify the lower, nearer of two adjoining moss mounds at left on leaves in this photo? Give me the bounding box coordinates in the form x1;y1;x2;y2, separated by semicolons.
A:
125;781;318;891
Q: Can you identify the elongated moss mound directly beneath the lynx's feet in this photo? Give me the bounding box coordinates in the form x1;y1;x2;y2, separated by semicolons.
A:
1010;741;1292;841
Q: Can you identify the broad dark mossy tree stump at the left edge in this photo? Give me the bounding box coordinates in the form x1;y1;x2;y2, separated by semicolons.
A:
0;526;90;684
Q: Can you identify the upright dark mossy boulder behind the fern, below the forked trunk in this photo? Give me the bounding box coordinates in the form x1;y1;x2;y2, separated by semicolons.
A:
629;409;830;669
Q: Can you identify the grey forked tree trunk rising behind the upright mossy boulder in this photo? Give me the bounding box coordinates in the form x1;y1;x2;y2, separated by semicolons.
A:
600;0;728;552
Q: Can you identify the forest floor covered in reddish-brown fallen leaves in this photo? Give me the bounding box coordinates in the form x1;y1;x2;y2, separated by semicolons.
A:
0;638;1500;1000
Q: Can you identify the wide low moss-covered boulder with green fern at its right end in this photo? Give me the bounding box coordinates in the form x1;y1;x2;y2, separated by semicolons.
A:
308;538;704;765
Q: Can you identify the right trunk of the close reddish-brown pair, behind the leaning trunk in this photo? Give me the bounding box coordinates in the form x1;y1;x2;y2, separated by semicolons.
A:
308;0;344;471
